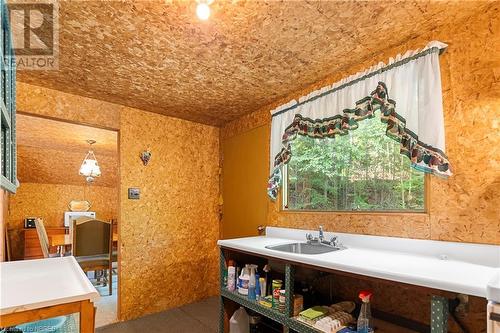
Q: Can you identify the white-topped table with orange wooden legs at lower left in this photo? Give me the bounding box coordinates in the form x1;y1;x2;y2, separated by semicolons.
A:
0;257;99;333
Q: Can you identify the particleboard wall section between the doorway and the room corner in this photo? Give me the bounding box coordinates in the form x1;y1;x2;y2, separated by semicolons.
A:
120;109;219;320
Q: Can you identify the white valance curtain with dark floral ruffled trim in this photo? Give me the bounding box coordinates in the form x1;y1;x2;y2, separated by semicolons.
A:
268;41;451;199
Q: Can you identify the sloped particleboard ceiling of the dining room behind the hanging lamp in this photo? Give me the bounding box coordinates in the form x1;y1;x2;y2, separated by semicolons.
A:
16;114;118;187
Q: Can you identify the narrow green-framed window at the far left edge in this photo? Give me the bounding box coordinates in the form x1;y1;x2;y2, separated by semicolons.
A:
0;1;16;192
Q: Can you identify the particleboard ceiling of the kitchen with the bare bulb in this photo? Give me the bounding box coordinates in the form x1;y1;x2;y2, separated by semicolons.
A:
18;0;484;125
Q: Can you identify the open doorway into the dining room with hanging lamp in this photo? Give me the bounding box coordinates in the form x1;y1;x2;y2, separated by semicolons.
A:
7;114;120;327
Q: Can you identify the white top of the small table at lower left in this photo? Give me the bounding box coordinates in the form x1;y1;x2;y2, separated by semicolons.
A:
0;257;99;315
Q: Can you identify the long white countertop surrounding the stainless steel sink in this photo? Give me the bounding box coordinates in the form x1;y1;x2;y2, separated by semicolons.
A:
218;228;500;302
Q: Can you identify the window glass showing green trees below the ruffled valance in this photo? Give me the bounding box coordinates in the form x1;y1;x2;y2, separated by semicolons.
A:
283;115;425;212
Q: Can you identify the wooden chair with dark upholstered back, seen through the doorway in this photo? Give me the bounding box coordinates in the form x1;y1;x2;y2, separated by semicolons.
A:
72;219;113;295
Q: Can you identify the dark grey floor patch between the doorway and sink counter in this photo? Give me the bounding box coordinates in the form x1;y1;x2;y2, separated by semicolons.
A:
96;297;219;333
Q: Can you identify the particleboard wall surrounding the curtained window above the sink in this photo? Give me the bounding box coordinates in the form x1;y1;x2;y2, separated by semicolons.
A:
221;2;500;244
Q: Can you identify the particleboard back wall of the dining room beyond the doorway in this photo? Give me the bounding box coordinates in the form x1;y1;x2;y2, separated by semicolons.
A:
7;183;118;259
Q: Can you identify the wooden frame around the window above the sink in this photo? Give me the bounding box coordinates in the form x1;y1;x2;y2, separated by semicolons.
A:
277;152;430;216
